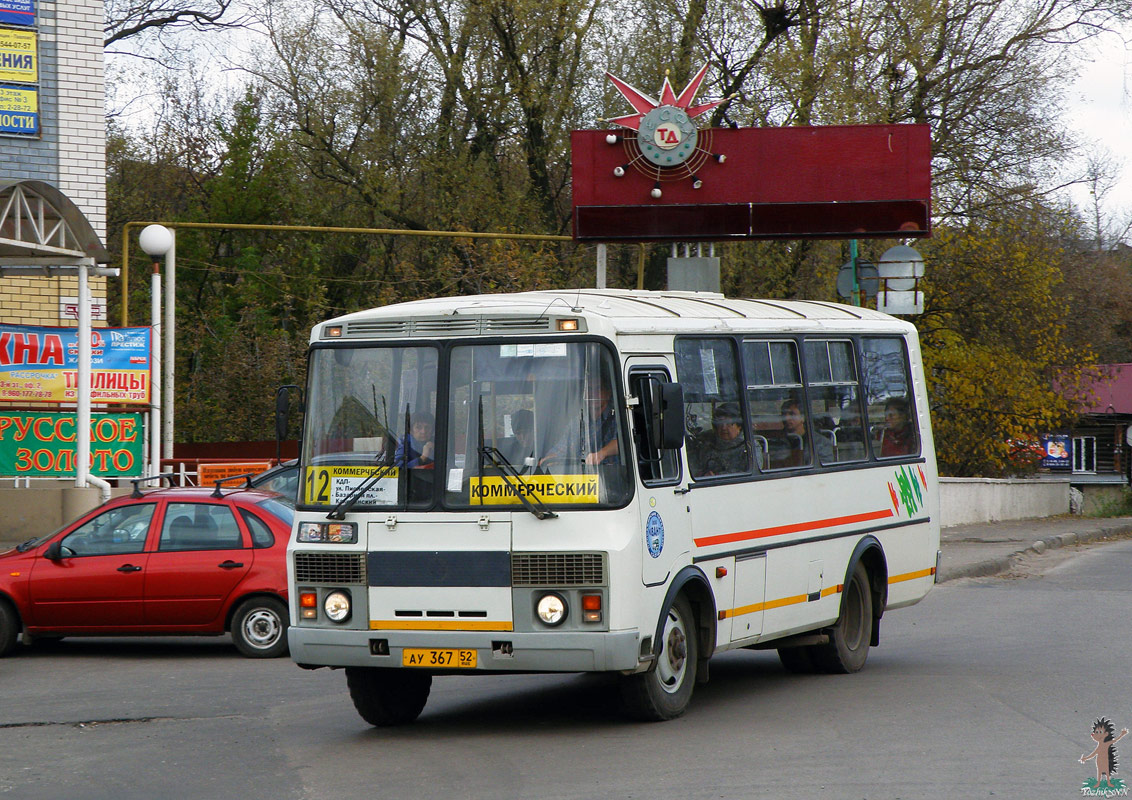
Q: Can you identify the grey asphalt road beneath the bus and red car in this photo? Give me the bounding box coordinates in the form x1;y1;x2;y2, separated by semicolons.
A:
0;541;1132;800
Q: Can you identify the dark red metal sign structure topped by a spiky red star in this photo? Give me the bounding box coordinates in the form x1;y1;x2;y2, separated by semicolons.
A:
572;70;932;241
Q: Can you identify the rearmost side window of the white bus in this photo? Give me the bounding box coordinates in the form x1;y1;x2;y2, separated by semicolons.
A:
860;337;919;458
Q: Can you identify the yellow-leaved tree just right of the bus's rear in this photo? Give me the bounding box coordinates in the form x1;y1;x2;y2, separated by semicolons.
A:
916;209;1095;476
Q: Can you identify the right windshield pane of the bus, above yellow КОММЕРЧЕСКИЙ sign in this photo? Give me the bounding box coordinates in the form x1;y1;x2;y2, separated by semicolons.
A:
445;342;629;507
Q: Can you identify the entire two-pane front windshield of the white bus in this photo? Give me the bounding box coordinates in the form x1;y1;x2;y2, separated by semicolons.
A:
301;341;632;510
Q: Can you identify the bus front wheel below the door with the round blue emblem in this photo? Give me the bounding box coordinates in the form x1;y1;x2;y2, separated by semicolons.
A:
621;595;700;722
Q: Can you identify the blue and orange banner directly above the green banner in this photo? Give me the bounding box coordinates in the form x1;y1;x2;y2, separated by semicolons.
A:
0;325;151;405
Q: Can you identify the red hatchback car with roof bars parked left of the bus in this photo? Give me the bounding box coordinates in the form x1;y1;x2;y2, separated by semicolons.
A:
0;489;293;659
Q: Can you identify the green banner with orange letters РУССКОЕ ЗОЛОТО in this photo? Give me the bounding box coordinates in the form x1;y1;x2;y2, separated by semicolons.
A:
0;411;144;478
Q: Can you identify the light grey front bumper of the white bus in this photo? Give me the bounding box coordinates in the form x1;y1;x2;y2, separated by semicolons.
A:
288;626;641;672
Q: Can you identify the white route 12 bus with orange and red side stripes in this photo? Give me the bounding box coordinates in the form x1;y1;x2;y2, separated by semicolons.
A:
288;290;940;725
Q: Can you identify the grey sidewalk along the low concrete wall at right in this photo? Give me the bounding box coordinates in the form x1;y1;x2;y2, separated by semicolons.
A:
938;515;1132;583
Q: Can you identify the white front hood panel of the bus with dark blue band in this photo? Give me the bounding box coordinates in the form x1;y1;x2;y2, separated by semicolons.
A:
367;509;513;630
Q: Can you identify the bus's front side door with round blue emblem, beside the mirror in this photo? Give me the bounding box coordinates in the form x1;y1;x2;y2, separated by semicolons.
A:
627;355;692;586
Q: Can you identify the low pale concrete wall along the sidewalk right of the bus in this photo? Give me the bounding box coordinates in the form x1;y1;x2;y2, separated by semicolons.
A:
940;478;1070;527
